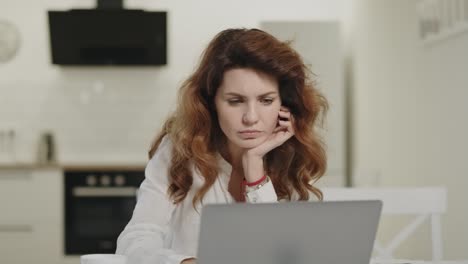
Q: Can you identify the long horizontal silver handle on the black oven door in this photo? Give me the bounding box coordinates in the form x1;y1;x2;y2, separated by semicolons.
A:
72;187;138;197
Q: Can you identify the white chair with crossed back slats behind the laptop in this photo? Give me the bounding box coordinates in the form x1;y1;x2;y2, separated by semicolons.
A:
322;188;447;261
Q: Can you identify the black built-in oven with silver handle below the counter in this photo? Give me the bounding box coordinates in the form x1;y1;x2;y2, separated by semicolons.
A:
64;168;144;255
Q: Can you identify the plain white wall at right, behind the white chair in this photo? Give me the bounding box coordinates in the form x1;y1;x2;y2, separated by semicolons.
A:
351;0;468;259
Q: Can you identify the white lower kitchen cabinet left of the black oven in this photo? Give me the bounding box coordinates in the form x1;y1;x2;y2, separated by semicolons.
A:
0;167;63;264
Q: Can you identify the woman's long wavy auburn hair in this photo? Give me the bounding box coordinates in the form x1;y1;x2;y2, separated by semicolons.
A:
149;28;328;206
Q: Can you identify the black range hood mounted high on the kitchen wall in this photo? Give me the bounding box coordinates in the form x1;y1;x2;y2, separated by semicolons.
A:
48;1;167;65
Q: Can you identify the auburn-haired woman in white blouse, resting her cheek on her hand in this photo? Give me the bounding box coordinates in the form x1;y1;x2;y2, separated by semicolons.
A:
117;29;327;264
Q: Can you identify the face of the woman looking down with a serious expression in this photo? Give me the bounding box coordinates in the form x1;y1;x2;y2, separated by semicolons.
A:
215;68;281;154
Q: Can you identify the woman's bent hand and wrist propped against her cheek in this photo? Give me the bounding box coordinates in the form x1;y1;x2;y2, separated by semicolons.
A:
242;106;294;182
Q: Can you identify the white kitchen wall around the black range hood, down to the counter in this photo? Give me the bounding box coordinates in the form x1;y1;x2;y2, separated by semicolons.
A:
0;0;343;163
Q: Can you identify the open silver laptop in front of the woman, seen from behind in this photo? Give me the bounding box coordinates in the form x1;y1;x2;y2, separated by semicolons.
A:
197;200;382;264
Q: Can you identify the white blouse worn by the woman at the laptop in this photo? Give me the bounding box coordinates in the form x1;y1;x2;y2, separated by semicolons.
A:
116;136;278;264
